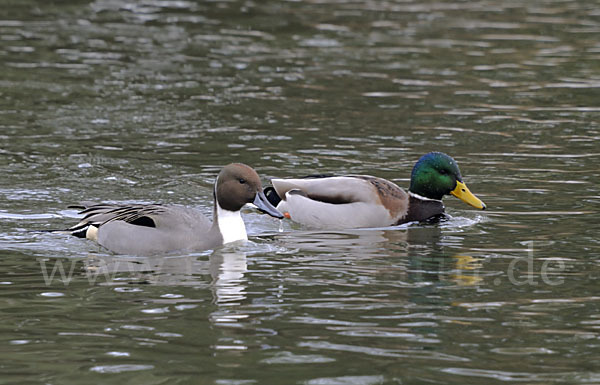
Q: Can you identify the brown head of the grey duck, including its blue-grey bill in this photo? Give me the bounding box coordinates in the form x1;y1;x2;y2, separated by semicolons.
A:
215;163;283;218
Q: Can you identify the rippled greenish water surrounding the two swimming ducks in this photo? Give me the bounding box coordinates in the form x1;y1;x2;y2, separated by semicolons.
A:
0;0;600;385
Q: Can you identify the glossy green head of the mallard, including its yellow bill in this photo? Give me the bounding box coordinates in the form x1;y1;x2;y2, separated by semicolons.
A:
408;152;485;210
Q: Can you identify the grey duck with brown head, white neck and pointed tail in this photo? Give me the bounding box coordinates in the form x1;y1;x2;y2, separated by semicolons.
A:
63;163;283;255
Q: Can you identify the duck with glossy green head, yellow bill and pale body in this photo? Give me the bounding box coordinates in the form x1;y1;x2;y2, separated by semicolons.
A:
265;152;486;229
